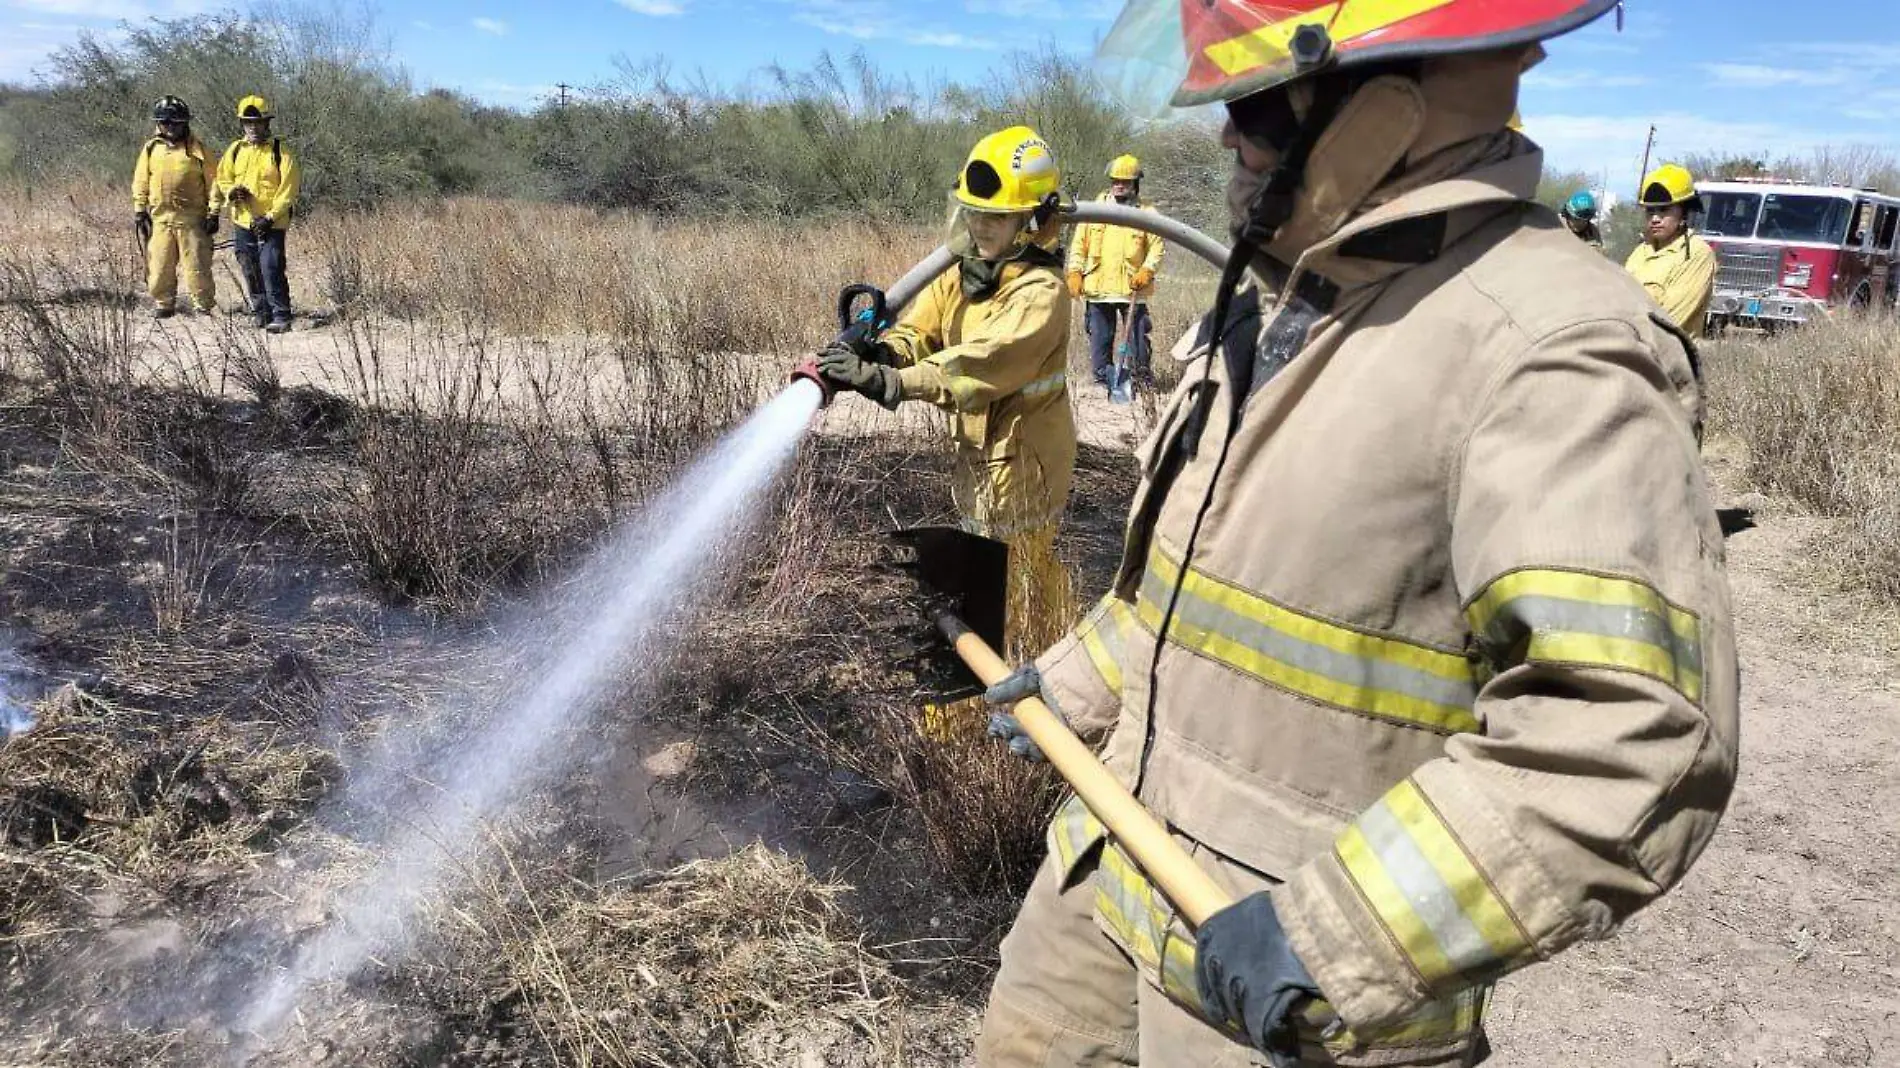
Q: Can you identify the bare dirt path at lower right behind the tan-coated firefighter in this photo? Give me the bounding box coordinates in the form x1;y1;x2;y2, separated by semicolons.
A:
1492;444;1900;1068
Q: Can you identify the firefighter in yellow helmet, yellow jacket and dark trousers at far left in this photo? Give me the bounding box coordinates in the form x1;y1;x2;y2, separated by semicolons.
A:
219;97;302;334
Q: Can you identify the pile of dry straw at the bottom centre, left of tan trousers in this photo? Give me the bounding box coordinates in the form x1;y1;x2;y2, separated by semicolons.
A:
440;846;923;1068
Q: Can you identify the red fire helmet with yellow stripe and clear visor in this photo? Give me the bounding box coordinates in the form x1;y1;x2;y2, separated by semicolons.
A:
1098;0;1619;110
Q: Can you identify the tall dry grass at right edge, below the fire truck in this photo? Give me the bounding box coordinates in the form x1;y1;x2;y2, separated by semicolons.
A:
1708;315;1900;601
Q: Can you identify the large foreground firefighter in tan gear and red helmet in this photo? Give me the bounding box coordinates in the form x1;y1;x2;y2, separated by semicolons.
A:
977;0;1739;1068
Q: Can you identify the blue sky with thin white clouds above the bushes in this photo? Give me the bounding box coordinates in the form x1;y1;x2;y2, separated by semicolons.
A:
0;0;1900;190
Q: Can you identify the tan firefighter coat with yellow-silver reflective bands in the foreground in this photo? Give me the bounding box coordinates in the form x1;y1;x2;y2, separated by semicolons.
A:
1037;148;1739;1064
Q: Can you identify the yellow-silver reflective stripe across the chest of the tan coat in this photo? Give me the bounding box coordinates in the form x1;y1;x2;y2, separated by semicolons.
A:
1136;540;1480;734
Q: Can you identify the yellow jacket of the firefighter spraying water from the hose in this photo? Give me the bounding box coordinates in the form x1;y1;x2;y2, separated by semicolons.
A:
884;254;1075;538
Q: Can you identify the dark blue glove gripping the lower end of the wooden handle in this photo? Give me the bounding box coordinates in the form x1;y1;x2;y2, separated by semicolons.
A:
1195;891;1321;1064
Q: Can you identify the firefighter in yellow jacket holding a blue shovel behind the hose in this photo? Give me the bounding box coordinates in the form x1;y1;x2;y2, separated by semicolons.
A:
1068;156;1165;390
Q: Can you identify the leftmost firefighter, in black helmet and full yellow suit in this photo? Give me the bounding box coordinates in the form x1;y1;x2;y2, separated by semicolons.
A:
131;97;219;319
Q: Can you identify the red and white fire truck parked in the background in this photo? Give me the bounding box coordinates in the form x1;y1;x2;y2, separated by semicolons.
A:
1697;179;1900;333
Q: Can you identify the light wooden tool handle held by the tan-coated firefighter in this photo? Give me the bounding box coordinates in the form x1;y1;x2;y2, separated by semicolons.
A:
937;614;1233;927
